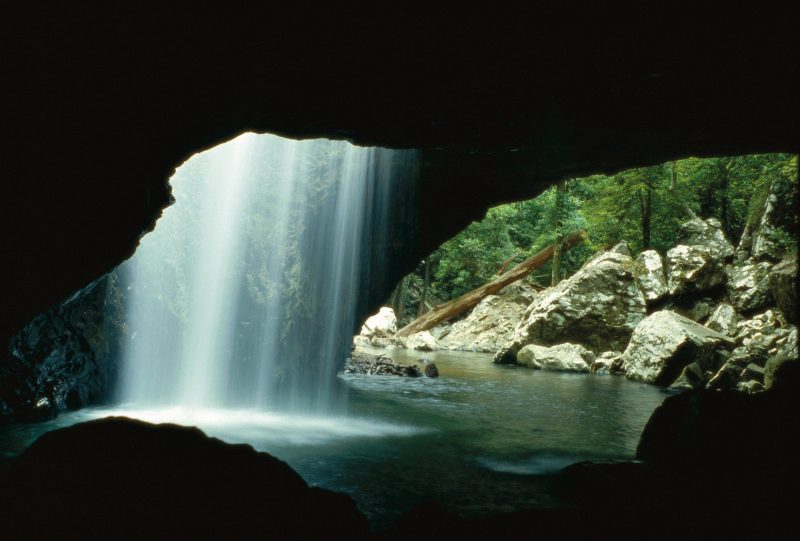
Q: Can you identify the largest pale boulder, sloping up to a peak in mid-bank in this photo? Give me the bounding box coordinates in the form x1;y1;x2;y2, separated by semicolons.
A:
495;247;646;363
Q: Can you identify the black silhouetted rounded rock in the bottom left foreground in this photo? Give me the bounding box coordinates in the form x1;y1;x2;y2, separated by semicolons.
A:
0;417;367;539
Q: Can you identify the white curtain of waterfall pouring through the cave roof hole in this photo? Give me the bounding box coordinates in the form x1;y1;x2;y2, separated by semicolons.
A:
119;134;417;411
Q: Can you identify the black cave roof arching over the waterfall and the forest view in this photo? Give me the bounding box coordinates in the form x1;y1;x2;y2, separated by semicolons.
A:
0;6;800;343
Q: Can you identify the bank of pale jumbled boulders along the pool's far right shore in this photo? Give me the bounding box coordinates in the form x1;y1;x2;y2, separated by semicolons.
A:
354;215;798;393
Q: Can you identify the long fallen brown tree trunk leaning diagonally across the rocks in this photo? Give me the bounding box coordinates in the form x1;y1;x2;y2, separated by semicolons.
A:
397;231;586;336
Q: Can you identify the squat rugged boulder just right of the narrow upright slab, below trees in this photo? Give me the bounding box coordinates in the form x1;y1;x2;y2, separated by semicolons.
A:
667;244;726;296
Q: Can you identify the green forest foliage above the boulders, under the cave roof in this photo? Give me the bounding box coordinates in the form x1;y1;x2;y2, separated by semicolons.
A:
416;154;798;300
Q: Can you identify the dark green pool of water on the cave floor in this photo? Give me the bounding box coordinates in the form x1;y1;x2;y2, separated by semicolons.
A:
0;350;666;527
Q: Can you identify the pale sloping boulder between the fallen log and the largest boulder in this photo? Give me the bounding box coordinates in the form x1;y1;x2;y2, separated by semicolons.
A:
438;284;537;353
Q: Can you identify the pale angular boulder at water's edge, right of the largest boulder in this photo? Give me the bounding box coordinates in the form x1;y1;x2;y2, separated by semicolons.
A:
623;310;733;385
